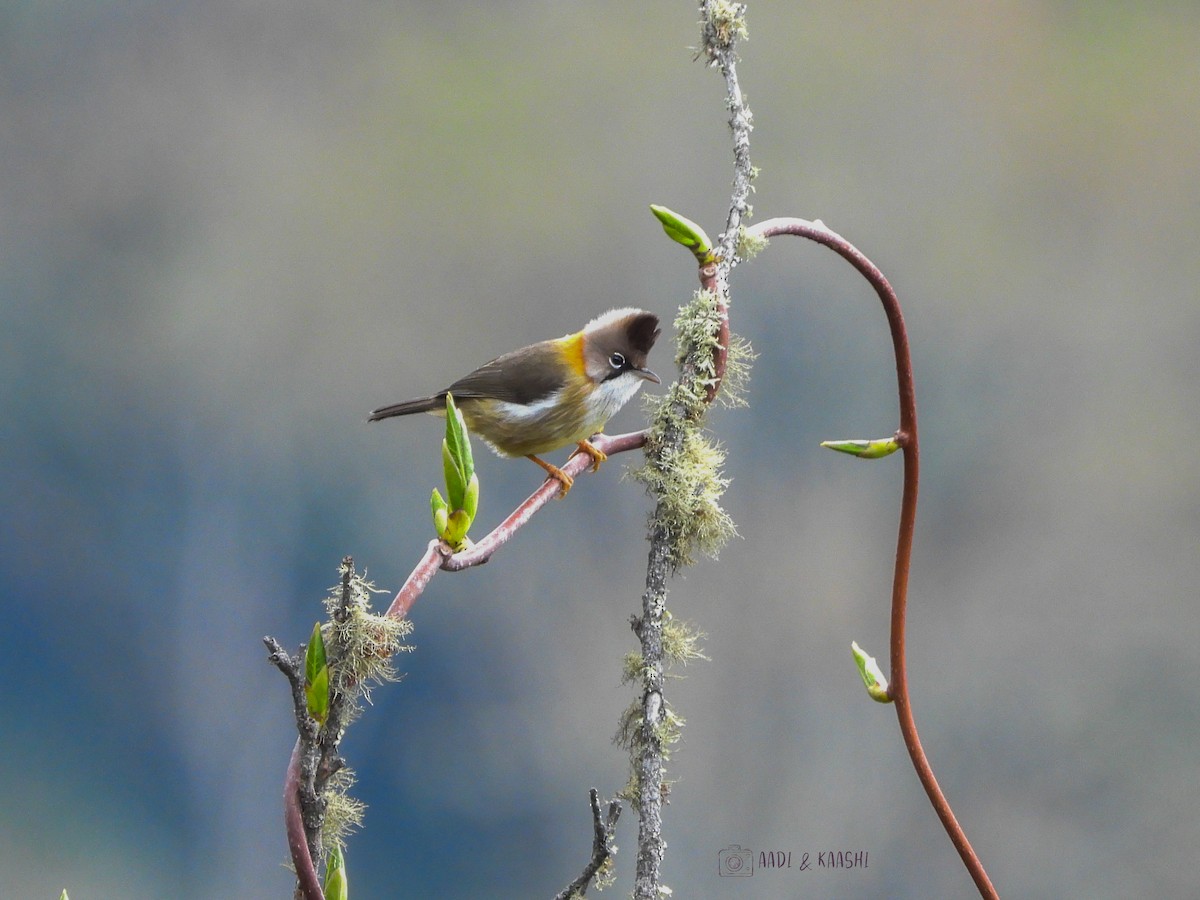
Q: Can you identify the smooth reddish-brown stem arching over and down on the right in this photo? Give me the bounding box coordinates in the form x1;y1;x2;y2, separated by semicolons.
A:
746;218;998;898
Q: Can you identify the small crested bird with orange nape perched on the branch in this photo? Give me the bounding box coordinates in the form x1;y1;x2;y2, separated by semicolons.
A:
367;307;662;498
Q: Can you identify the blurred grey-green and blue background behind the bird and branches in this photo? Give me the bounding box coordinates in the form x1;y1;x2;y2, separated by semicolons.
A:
0;0;1200;900
